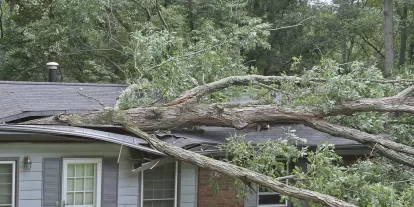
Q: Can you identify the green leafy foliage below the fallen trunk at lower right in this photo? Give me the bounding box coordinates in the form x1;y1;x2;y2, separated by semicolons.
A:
222;137;414;207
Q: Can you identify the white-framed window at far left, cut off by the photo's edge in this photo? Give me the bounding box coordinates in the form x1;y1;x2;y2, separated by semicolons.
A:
0;161;16;207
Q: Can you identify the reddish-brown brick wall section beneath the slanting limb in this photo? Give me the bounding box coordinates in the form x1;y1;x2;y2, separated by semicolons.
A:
197;168;243;207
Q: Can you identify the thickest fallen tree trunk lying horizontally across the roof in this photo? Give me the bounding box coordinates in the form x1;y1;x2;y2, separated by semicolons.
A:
27;104;414;167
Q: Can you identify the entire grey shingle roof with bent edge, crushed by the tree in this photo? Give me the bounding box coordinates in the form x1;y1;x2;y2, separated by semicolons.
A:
0;81;362;152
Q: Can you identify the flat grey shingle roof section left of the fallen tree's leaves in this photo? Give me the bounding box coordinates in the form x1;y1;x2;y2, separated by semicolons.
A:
0;81;127;123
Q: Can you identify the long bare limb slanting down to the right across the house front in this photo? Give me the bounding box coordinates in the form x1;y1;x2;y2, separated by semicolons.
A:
125;123;355;207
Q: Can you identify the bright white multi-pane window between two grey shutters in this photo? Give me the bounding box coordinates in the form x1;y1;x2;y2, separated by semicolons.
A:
62;159;102;207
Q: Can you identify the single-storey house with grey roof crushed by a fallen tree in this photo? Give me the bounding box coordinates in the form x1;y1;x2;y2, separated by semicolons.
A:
0;64;367;207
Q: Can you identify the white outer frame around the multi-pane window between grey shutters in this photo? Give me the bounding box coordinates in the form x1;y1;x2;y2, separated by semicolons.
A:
62;158;102;207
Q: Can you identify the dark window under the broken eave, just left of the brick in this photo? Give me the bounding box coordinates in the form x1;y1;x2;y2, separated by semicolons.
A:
141;162;177;207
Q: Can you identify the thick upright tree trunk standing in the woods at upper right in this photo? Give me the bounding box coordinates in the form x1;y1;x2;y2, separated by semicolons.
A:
384;0;394;76
